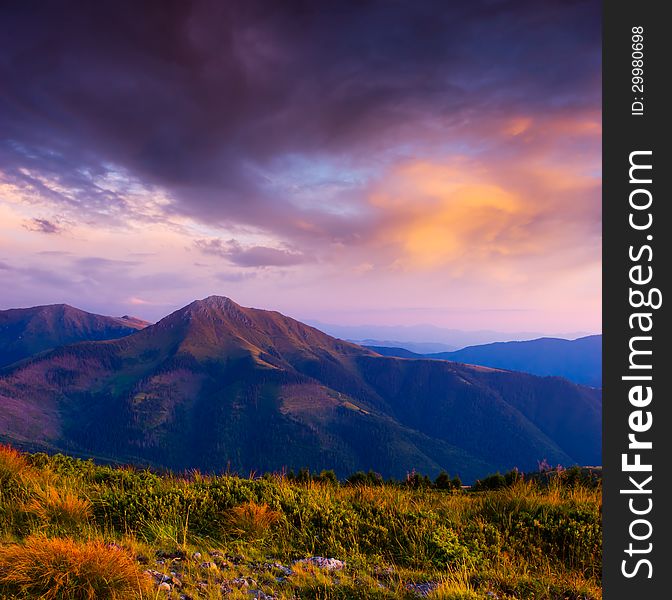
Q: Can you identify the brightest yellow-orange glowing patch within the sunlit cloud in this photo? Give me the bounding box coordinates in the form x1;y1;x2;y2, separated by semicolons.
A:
371;160;536;268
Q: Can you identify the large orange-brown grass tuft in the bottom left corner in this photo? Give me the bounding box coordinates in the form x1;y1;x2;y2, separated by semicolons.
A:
0;537;150;600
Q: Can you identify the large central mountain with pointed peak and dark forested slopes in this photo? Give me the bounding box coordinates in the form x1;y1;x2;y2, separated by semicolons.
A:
0;297;601;481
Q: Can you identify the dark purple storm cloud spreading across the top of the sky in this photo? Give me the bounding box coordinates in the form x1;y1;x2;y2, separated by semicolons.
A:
0;0;600;239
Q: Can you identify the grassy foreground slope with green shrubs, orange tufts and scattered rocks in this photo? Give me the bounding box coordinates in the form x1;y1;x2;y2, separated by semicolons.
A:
0;446;601;600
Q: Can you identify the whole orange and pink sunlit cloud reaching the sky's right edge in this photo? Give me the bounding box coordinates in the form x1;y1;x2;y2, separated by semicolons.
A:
368;114;600;281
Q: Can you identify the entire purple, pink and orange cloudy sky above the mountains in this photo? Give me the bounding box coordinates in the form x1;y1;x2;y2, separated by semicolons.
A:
0;0;601;332
